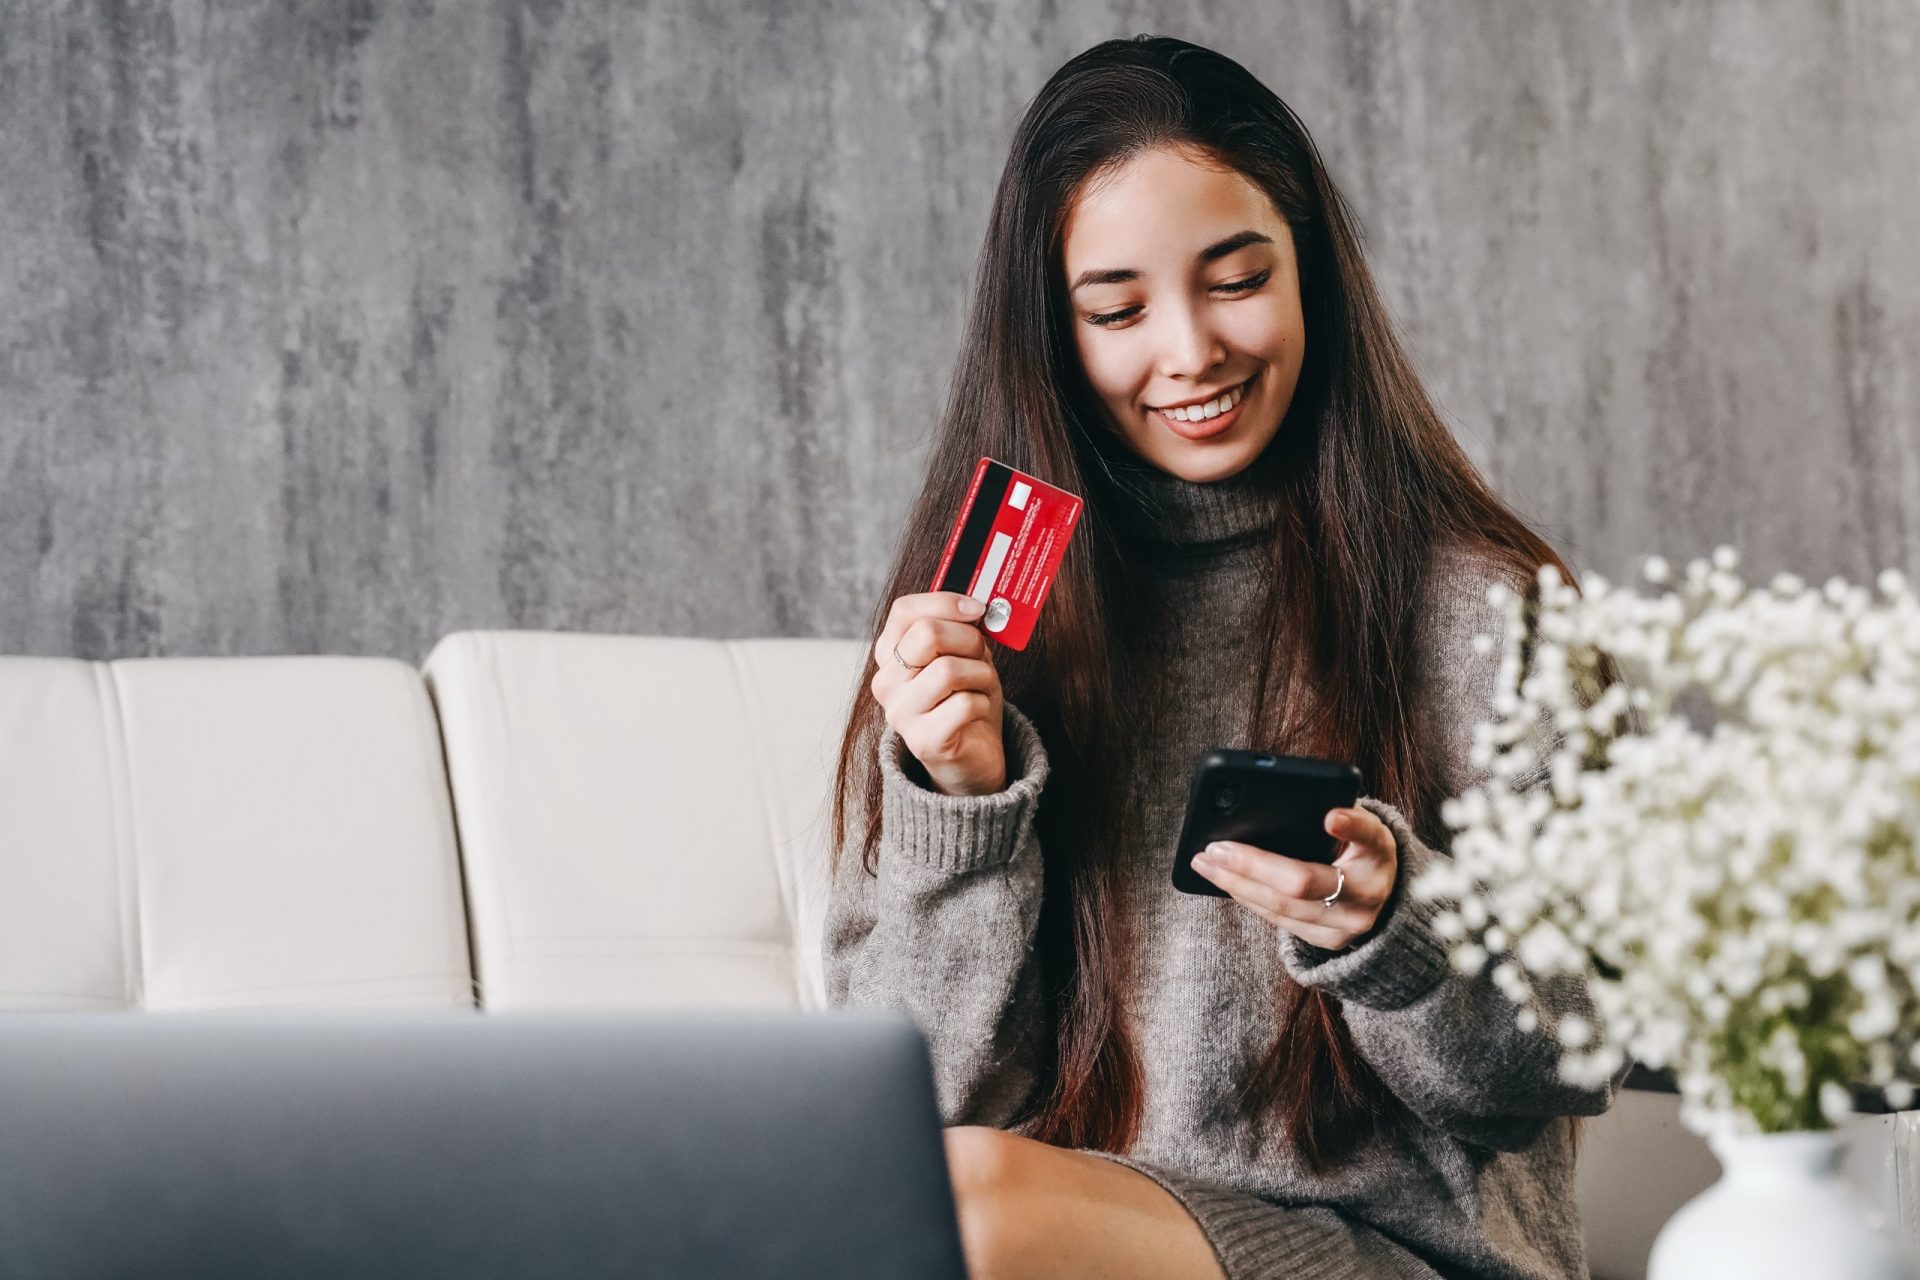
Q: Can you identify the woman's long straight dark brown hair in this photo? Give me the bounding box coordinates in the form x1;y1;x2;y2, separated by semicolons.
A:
833;35;1612;1167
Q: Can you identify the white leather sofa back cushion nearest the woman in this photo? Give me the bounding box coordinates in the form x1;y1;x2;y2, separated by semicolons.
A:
424;631;864;1007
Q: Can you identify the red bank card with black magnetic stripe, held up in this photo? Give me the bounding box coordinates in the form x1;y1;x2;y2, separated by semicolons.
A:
929;459;1081;649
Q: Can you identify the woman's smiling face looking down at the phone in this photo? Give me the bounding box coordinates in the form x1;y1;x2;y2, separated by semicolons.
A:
1064;148;1306;484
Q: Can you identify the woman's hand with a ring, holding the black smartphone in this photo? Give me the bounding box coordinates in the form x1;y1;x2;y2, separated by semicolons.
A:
1194;806;1400;952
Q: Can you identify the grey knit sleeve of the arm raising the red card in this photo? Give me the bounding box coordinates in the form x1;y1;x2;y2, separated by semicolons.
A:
822;702;1048;1128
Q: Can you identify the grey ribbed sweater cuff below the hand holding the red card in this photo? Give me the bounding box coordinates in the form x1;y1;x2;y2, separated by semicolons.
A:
879;700;1050;871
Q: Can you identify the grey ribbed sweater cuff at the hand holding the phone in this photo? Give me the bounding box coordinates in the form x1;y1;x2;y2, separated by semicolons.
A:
1279;796;1452;1009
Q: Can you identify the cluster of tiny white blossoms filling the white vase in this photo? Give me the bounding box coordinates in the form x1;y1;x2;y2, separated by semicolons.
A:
1409;547;1920;1134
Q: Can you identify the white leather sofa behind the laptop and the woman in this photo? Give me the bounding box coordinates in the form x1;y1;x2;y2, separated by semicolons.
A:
0;631;1920;1280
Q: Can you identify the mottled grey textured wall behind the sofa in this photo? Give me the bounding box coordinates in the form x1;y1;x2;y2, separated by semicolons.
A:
0;0;1920;660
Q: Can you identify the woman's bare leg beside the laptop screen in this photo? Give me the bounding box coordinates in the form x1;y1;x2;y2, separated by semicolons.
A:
947;1125;1225;1280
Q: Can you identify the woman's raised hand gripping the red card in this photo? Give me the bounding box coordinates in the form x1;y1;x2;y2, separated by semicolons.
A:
872;591;1006;796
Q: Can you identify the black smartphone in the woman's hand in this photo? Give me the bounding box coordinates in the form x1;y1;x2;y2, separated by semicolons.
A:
1173;747;1359;898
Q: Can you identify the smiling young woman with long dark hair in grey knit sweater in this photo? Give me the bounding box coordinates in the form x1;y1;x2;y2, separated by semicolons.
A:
826;36;1611;1280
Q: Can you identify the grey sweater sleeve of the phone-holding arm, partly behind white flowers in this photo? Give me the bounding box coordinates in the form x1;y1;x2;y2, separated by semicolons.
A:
1281;545;1613;1150
